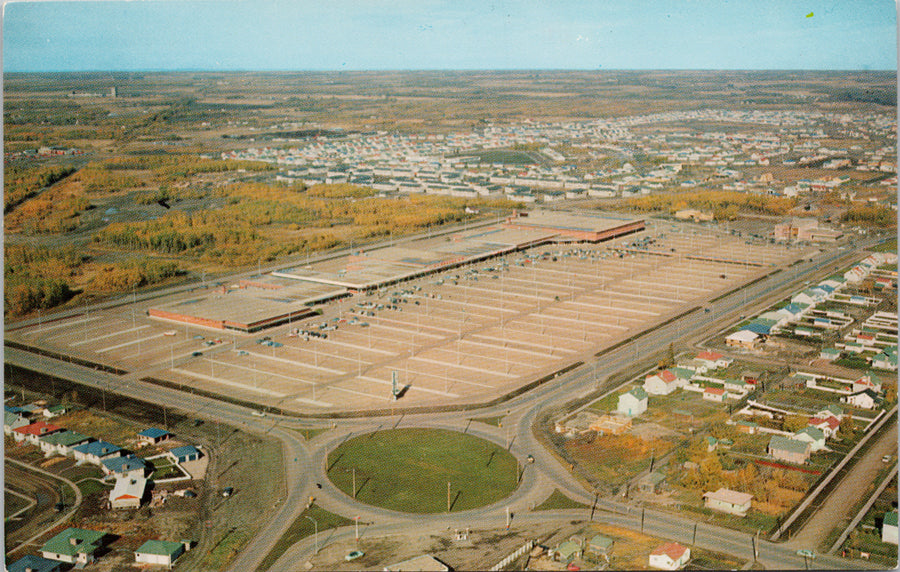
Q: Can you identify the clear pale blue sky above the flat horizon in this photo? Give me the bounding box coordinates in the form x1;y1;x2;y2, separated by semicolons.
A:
2;0;897;72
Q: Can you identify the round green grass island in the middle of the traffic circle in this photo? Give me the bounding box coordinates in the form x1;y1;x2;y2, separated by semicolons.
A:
328;429;518;513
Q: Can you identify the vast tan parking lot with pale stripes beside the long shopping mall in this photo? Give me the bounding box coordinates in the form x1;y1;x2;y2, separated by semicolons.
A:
3;217;804;413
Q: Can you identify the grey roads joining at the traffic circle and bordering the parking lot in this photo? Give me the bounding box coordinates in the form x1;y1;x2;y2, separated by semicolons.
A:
6;235;884;572
